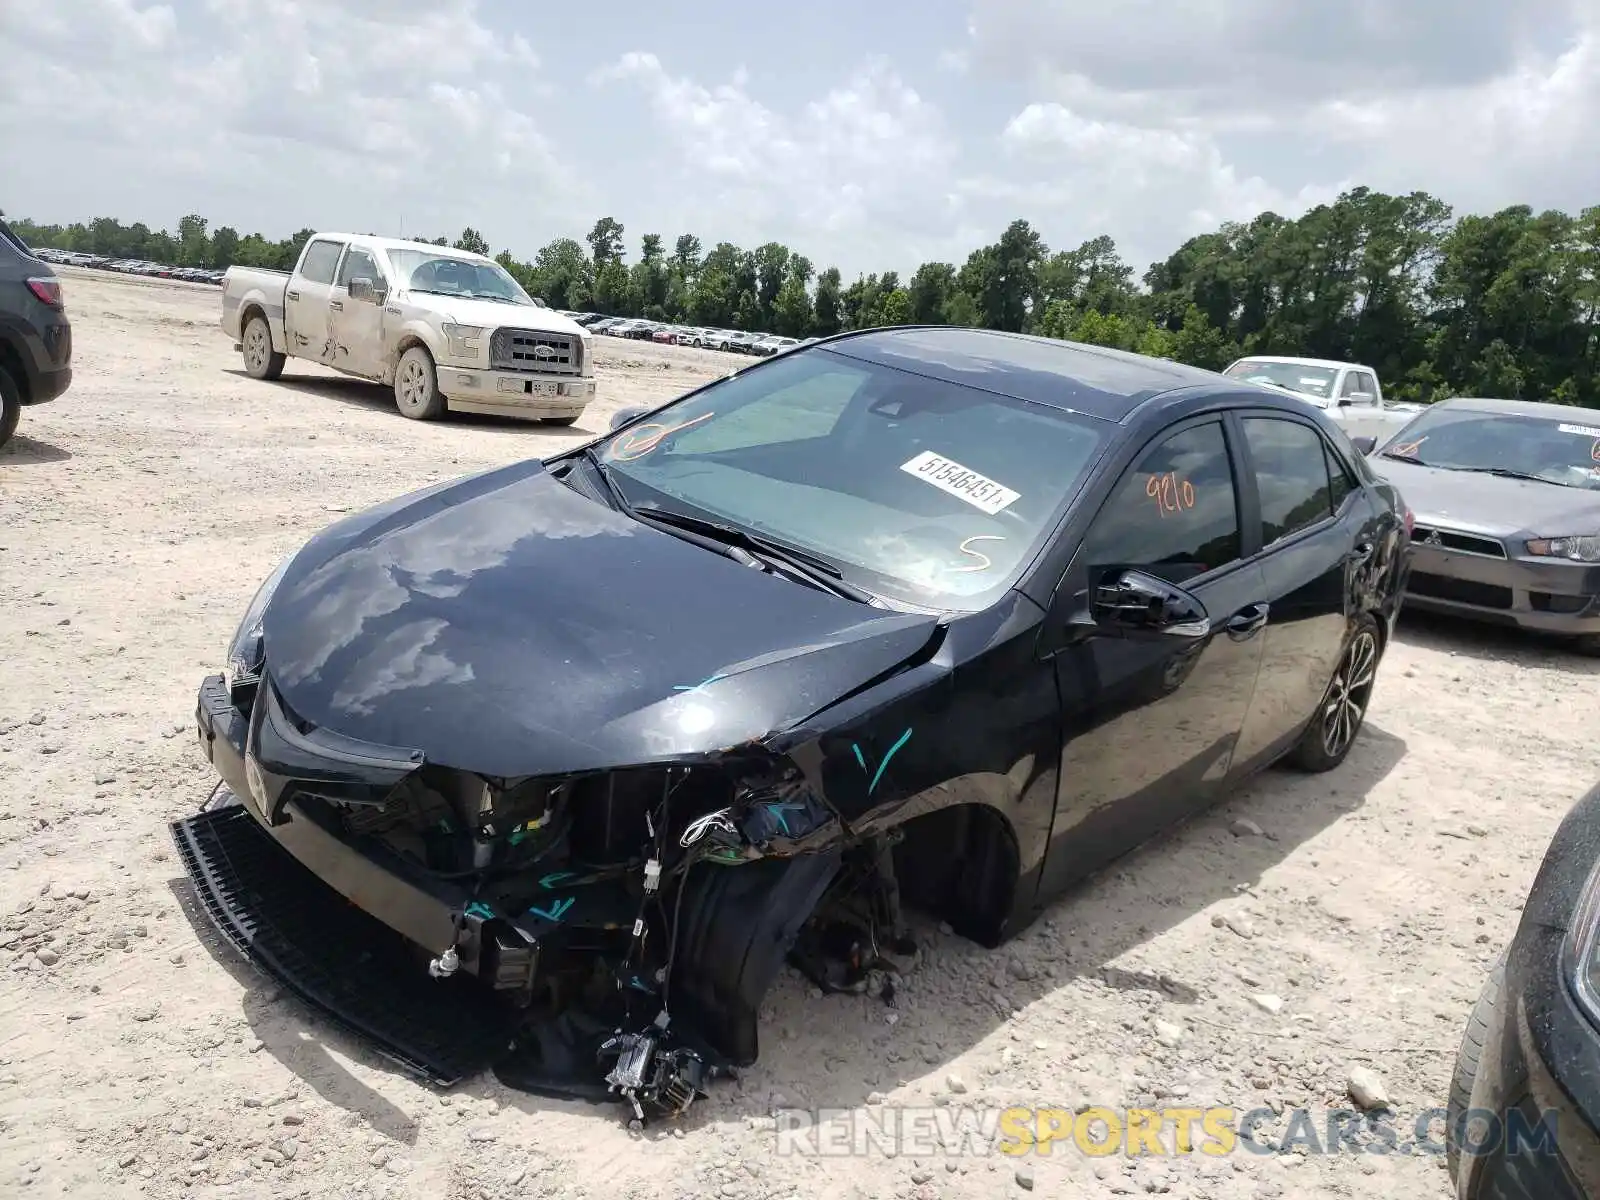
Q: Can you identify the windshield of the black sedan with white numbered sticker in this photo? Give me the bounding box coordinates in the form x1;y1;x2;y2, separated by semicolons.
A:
602;350;1110;611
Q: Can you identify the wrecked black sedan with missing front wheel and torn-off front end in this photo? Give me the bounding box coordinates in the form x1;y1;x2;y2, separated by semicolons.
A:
173;328;1410;1120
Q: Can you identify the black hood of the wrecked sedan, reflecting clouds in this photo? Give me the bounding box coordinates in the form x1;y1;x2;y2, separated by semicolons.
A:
262;461;936;776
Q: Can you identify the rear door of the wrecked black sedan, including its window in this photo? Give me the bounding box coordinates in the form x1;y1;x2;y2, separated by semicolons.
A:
1235;410;1378;771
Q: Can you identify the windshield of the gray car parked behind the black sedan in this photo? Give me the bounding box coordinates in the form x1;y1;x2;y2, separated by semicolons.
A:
1381;408;1600;491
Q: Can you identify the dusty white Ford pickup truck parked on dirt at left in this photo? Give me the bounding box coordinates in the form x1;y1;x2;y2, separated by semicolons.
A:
222;234;595;426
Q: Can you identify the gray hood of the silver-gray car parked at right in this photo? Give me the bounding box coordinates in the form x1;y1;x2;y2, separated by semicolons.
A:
1366;454;1600;538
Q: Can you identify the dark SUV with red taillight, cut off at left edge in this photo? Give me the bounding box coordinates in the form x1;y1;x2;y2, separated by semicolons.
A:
0;221;72;446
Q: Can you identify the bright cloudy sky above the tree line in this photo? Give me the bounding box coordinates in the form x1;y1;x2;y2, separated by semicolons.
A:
0;0;1600;280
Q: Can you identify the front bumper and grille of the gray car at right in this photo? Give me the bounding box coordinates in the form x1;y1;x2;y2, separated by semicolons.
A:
1405;542;1600;635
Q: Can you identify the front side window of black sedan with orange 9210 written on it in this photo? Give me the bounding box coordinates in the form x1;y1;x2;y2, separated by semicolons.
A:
1078;421;1240;584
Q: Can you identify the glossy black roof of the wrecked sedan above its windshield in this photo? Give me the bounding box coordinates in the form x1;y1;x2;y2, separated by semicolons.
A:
811;325;1237;422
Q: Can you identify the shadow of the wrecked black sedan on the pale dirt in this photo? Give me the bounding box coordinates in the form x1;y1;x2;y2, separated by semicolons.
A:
170;723;1406;1144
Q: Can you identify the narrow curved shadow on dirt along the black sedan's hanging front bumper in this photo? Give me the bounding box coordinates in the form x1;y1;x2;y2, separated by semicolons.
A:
166;877;418;1146
